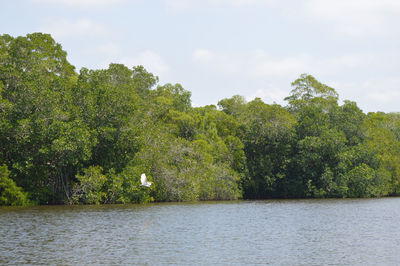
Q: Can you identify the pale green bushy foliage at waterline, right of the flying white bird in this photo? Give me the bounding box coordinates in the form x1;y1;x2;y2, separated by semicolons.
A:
135;129;240;201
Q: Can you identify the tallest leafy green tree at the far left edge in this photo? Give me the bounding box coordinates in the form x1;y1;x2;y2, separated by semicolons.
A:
0;33;84;203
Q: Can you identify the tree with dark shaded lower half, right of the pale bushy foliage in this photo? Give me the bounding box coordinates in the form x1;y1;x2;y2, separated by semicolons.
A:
233;98;296;198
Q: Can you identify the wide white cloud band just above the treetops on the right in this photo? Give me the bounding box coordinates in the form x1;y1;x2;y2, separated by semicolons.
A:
192;49;400;111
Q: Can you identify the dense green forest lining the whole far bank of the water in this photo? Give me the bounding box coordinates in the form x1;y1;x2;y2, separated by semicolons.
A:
0;33;400;205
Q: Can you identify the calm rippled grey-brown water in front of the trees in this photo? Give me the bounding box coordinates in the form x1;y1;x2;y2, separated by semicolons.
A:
0;198;400;265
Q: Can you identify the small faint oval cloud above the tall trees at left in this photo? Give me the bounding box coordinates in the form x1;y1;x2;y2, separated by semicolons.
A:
40;18;111;38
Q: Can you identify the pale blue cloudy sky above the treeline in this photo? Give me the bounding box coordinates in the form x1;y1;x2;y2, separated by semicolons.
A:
0;0;400;112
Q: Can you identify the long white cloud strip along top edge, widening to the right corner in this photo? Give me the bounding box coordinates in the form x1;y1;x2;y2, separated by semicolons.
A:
164;0;400;38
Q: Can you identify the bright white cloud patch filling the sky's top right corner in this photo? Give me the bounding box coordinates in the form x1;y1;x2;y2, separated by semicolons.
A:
304;0;400;37
